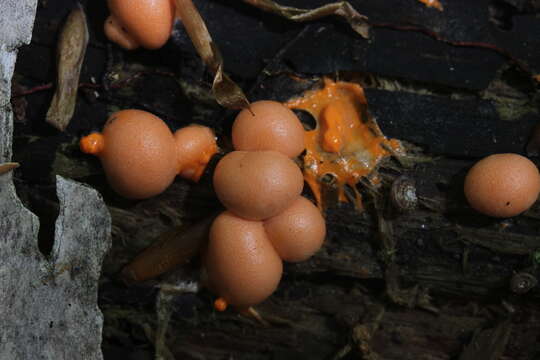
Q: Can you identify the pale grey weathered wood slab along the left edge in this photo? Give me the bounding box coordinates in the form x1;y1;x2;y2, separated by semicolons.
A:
0;0;111;360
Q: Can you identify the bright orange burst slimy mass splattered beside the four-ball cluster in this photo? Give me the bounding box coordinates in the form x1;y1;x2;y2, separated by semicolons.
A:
285;79;402;206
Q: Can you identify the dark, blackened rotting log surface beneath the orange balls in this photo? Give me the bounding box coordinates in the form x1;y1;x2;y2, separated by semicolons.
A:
8;0;540;359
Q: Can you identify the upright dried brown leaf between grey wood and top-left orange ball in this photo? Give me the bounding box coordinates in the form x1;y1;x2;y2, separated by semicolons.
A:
46;5;89;131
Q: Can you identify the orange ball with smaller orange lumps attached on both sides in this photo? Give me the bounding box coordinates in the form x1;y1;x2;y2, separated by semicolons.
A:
80;110;217;199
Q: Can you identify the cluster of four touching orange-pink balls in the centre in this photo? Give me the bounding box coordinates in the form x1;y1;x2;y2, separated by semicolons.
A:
203;101;326;311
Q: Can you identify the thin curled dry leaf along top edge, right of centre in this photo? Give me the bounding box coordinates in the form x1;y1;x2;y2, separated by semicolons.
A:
242;0;369;39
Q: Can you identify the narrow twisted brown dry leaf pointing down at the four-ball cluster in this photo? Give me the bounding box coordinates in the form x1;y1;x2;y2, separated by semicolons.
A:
176;0;249;109
